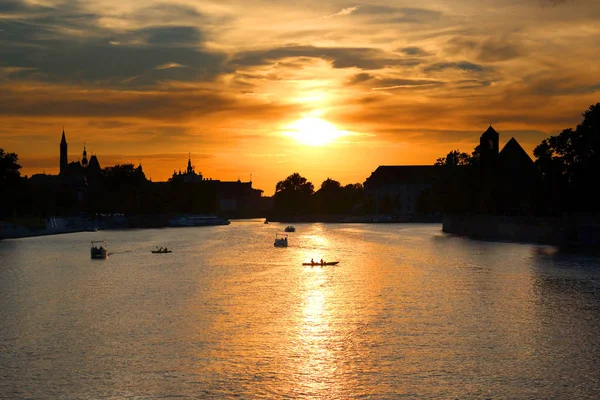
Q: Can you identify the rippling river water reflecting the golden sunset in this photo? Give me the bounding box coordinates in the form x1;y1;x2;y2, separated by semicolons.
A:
0;220;600;399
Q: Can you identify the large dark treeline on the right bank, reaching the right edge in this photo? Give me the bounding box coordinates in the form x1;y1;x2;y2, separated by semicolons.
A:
432;103;600;216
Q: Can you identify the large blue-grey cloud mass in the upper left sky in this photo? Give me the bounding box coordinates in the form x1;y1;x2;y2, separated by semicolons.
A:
0;1;227;87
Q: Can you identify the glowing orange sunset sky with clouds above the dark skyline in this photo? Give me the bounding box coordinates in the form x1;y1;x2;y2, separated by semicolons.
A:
0;0;600;195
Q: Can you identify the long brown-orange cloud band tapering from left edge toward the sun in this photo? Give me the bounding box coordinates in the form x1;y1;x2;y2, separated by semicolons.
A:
0;85;291;123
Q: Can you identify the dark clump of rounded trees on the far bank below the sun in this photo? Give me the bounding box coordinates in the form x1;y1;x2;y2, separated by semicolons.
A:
270;173;375;218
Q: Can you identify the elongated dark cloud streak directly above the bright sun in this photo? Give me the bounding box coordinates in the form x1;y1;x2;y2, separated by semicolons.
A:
231;46;419;69
